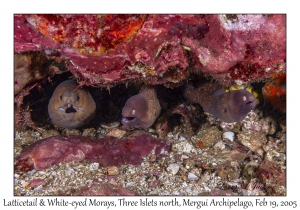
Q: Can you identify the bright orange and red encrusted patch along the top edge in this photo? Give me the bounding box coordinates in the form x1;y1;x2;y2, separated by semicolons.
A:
25;14;146;55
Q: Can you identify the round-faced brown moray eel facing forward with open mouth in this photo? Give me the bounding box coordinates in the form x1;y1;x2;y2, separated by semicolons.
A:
48;80;96;128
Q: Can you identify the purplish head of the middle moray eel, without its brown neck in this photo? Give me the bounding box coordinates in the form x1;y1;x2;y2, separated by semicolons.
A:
121;94;148;127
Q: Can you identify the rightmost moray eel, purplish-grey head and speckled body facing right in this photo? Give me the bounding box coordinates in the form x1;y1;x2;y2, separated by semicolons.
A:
184;82;256;123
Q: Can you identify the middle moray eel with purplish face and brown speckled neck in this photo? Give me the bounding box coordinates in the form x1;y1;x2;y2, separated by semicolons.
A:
121;86;161;129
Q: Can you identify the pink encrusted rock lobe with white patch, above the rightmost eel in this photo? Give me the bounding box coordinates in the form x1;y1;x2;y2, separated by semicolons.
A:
183;15;286;84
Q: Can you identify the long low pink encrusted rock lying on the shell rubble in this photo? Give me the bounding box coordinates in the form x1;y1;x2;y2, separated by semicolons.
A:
16;134;171;170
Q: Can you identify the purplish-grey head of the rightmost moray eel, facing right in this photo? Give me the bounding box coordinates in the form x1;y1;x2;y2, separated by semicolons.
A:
229;90;256;122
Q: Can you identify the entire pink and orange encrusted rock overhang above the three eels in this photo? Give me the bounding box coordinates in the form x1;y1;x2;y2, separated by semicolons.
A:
15;14;286;87
